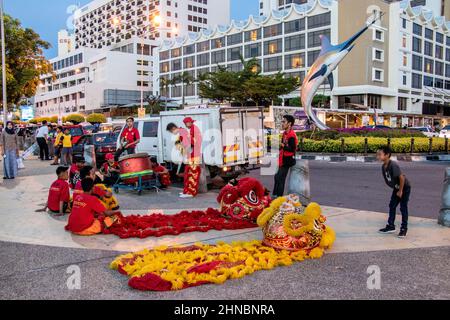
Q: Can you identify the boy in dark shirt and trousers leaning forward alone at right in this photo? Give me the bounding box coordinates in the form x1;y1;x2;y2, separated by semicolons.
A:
377;147;411;238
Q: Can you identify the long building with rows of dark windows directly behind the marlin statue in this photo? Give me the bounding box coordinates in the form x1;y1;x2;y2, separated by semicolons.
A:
154;0;450;127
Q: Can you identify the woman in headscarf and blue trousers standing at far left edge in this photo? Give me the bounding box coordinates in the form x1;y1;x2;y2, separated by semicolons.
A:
0;121;19;180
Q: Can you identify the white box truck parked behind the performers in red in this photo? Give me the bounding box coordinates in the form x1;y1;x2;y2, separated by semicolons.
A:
118;107;266;178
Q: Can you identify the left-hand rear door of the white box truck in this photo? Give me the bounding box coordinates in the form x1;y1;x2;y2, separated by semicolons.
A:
221;110;245;166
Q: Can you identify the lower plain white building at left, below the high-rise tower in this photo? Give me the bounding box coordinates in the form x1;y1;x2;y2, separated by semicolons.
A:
34;42;152;116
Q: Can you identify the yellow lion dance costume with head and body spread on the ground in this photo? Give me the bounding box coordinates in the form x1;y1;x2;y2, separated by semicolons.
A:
111;195;336;291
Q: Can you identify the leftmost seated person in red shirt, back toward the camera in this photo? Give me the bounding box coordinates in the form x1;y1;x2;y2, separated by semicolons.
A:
47;167;70;215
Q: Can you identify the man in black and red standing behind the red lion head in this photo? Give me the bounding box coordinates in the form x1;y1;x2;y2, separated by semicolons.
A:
273;115;298;199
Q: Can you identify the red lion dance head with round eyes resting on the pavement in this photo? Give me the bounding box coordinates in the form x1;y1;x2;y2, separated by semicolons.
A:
217;178;271;222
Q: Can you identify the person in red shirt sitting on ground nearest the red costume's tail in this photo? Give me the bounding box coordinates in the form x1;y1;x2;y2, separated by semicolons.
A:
66;178;120;236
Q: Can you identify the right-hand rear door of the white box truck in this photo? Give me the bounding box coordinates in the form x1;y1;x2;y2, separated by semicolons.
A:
241;109;265;164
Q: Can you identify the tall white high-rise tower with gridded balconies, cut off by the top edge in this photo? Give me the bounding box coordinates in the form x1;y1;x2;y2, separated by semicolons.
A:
74;0;230;49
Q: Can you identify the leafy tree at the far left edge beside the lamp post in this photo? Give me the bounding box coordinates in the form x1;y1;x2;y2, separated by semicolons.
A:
0;15;51;104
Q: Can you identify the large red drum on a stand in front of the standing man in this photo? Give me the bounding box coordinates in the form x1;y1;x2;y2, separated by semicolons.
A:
119;153;153;184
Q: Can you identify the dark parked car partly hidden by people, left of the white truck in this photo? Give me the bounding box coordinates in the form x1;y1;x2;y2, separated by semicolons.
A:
73;132;119;166
